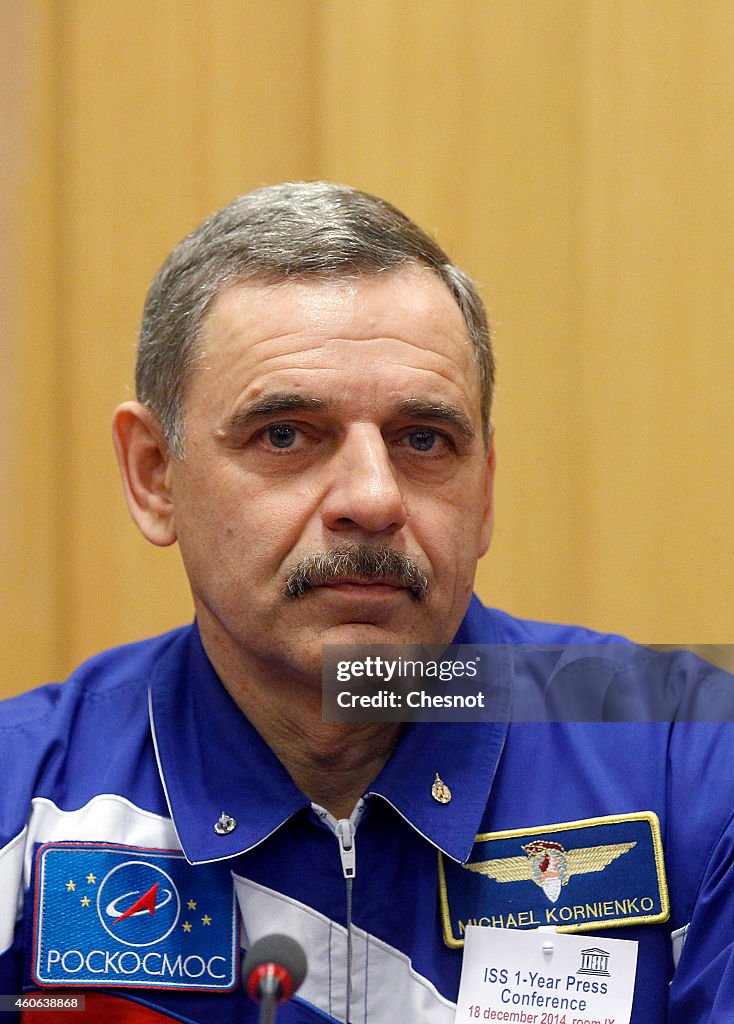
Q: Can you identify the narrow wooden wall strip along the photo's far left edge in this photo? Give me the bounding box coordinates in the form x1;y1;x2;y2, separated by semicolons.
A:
0;0;60;694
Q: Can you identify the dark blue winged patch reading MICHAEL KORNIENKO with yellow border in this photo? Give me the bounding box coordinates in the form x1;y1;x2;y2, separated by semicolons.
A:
438;811;670;947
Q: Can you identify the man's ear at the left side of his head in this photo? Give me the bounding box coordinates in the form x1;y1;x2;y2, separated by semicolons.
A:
113;401;176;548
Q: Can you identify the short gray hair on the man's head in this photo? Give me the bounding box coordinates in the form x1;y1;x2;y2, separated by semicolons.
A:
135;181;494;457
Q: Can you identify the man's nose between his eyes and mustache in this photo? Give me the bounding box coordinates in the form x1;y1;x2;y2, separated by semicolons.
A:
321;424;407;536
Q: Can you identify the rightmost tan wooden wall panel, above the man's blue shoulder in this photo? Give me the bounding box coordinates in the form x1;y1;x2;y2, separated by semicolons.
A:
578;3;734;643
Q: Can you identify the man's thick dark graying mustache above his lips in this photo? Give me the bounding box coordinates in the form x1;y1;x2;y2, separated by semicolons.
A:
286;544;428;601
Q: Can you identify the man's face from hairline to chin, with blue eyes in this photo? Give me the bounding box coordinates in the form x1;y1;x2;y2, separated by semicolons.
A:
168;268;493;681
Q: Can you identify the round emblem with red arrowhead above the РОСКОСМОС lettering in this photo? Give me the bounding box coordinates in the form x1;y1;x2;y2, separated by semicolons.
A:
97;860;181;947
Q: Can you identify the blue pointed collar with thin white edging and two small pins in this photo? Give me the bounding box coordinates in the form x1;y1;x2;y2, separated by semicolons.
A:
149;606;513;863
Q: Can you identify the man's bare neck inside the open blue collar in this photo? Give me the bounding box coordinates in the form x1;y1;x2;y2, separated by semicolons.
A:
200;622;400;818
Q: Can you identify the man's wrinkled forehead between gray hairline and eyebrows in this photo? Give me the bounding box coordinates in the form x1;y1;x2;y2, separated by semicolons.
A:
191;267;479;395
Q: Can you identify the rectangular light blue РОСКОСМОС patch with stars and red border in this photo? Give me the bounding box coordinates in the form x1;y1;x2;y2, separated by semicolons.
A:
33;843;240;991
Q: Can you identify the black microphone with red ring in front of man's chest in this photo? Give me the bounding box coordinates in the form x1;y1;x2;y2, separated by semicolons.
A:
243;935;306;1024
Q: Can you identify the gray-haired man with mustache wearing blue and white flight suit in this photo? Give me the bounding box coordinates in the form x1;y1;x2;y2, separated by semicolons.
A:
0;183;734;1024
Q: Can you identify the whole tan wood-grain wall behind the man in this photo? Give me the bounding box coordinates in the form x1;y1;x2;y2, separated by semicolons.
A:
0;0;734;693
